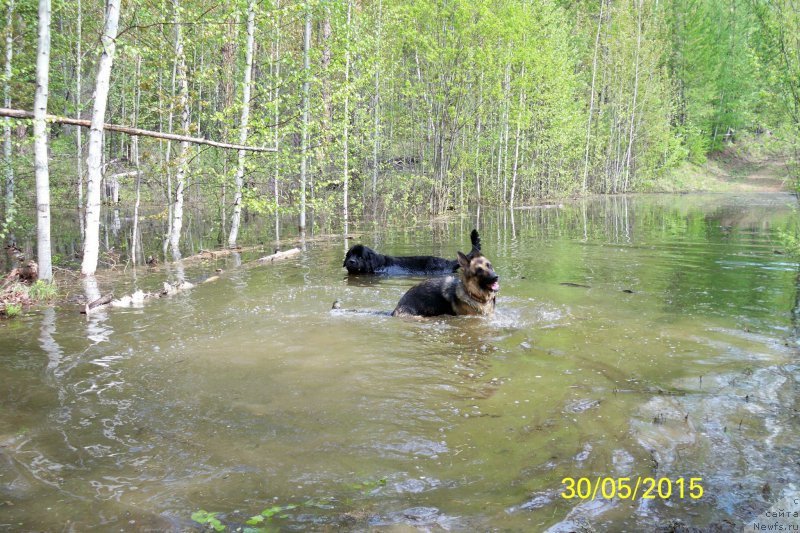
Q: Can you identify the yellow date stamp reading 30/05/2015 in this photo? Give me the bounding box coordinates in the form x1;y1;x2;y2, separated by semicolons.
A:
561;476;703;500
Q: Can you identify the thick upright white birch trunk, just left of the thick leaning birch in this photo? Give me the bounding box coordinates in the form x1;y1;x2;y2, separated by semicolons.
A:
33;0;53;281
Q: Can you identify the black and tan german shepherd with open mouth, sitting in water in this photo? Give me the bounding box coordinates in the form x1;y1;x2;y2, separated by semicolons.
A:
392;251;500;316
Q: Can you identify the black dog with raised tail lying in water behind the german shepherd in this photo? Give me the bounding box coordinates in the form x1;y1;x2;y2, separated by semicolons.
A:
342;230;481;275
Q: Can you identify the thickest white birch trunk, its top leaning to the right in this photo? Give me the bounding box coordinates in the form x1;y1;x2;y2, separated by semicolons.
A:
81;0;121;276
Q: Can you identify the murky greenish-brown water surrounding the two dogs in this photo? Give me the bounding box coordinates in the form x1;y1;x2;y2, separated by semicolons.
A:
0;195;800;531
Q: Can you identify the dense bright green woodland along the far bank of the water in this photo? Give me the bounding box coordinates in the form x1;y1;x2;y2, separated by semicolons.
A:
2;0;800;273
